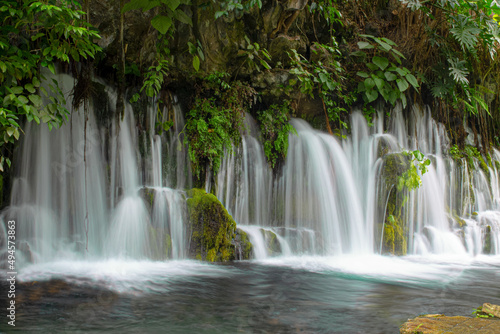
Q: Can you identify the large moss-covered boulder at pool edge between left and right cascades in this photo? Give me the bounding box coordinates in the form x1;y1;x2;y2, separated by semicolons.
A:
187;189;236;262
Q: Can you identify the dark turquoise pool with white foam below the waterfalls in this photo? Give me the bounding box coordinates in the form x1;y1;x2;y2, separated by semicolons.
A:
0;256;500;333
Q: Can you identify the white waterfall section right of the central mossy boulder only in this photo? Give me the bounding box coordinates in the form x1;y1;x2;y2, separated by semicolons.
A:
217;107;500;258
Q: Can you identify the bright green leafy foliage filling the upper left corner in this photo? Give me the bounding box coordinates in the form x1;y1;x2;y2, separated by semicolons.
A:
0;0;100;170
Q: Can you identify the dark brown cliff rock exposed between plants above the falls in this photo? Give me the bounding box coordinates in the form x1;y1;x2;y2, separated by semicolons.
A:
88;0;323;121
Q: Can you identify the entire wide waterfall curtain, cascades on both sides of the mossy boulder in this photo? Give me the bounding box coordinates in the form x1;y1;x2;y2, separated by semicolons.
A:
0;75;500;264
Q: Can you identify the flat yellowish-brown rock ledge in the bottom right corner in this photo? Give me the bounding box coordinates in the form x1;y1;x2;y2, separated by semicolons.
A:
400;303;500;334
